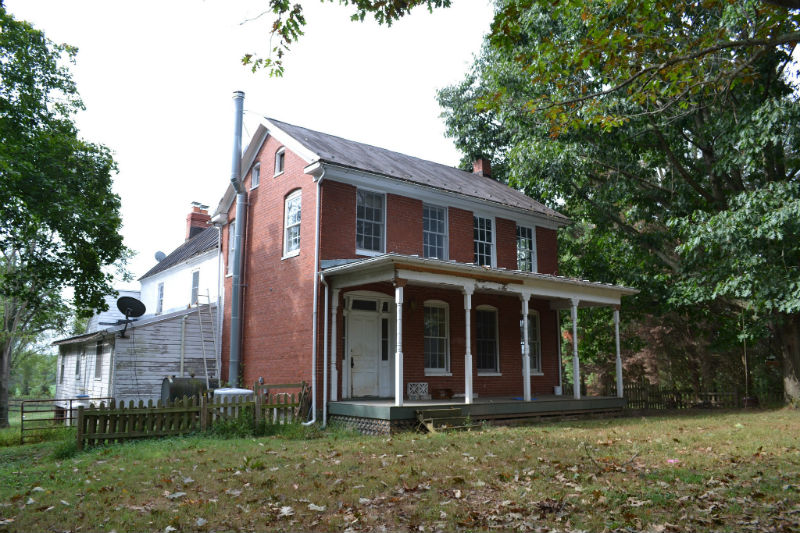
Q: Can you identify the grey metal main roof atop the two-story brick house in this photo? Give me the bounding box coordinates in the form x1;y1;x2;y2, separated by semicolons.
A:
267;118;569;223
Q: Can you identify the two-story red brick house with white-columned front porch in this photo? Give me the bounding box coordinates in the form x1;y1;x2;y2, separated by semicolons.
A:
215;114;636;430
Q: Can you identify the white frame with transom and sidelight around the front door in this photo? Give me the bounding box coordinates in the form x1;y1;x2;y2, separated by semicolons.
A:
340;290;397;399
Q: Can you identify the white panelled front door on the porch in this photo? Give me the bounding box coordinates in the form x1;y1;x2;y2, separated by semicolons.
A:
347;312;380;397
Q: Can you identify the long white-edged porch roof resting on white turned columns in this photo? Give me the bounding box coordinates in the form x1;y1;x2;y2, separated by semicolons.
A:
322;253;639;309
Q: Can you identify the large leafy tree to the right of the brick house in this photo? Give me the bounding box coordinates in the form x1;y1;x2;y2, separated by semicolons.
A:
439;0;800;401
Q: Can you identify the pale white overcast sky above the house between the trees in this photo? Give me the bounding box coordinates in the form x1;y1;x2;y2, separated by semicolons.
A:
6;0;492;288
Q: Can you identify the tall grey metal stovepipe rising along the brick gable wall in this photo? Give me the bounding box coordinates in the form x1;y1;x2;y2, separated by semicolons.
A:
228;91;247;387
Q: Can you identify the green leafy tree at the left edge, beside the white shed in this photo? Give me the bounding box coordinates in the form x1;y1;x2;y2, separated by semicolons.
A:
0;3;126;427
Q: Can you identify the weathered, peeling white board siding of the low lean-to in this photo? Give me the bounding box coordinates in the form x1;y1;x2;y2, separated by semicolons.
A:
113;306;216;402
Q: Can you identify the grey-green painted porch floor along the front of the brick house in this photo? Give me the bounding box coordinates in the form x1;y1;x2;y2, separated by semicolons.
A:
328;395;625;421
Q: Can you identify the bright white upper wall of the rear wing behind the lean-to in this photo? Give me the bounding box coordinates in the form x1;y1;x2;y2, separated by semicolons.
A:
141;248;219;316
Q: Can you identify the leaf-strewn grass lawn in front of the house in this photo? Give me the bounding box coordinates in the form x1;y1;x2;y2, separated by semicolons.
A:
0;409;800;532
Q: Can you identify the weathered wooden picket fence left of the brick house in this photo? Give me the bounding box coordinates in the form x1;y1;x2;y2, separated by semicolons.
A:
77;383;308;449
